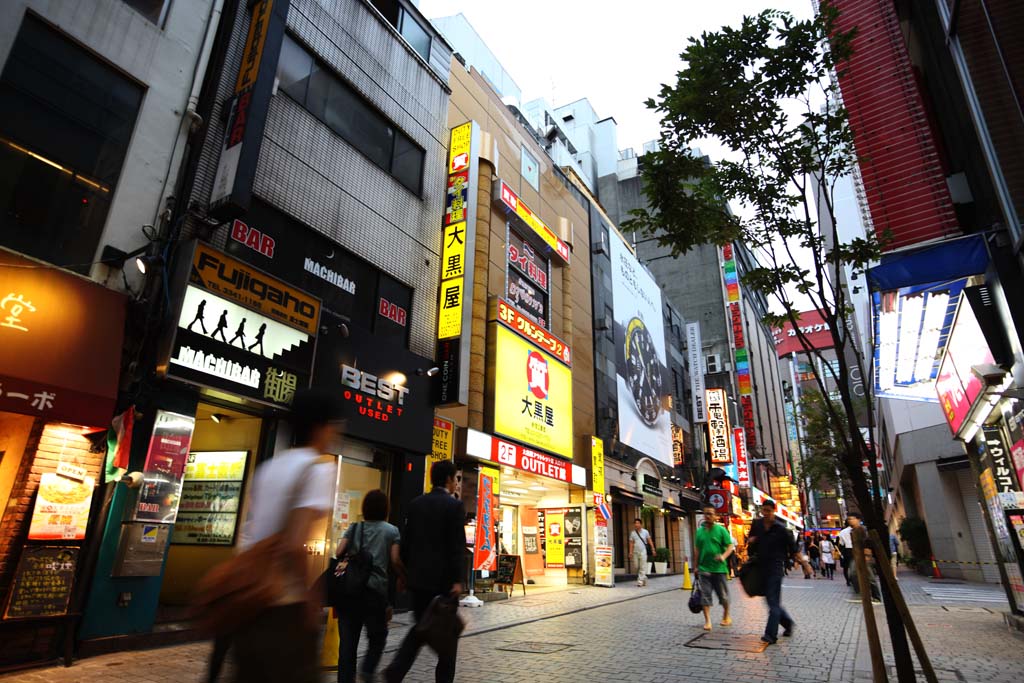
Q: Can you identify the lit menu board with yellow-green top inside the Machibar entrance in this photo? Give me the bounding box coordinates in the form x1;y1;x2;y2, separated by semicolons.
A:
171;451;249;546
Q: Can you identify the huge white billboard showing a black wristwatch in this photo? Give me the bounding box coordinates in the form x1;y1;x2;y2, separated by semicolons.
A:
610;233;672;467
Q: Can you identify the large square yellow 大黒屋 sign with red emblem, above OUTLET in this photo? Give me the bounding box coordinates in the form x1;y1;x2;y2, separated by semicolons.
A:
490;324;572;460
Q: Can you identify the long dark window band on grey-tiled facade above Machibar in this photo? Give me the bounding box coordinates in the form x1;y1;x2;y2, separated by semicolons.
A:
278;36;425;195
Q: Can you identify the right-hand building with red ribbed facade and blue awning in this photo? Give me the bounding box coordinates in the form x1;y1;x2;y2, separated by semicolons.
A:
837;0;1024;609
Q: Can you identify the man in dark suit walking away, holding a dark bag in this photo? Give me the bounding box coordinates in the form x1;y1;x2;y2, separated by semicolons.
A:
384;460;466;683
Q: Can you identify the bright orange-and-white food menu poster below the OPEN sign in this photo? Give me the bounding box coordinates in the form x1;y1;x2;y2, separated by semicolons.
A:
29;472;96;541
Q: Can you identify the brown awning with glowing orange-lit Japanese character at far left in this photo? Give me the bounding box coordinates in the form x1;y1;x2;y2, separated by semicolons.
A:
0;249;127;427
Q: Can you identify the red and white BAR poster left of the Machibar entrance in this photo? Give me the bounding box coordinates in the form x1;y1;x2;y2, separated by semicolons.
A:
135;411;196;524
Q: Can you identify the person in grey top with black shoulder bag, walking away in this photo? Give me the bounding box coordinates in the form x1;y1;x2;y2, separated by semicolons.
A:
334;489;403;683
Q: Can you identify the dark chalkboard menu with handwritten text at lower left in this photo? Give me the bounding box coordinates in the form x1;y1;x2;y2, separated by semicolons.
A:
4;546;79;618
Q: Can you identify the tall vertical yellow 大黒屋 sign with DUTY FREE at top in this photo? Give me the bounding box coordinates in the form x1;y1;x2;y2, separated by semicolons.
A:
436;121;478;405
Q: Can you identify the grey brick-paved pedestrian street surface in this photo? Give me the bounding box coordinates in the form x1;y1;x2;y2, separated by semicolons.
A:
0;572;1024;683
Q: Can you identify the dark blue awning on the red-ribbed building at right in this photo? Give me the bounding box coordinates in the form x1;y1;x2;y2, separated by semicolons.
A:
867;233;988;292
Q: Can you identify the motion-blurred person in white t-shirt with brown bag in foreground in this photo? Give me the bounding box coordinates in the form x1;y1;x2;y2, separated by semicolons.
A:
231;390;340;683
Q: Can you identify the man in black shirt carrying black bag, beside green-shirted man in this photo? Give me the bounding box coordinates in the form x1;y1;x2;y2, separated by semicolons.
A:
746;500;797;645
